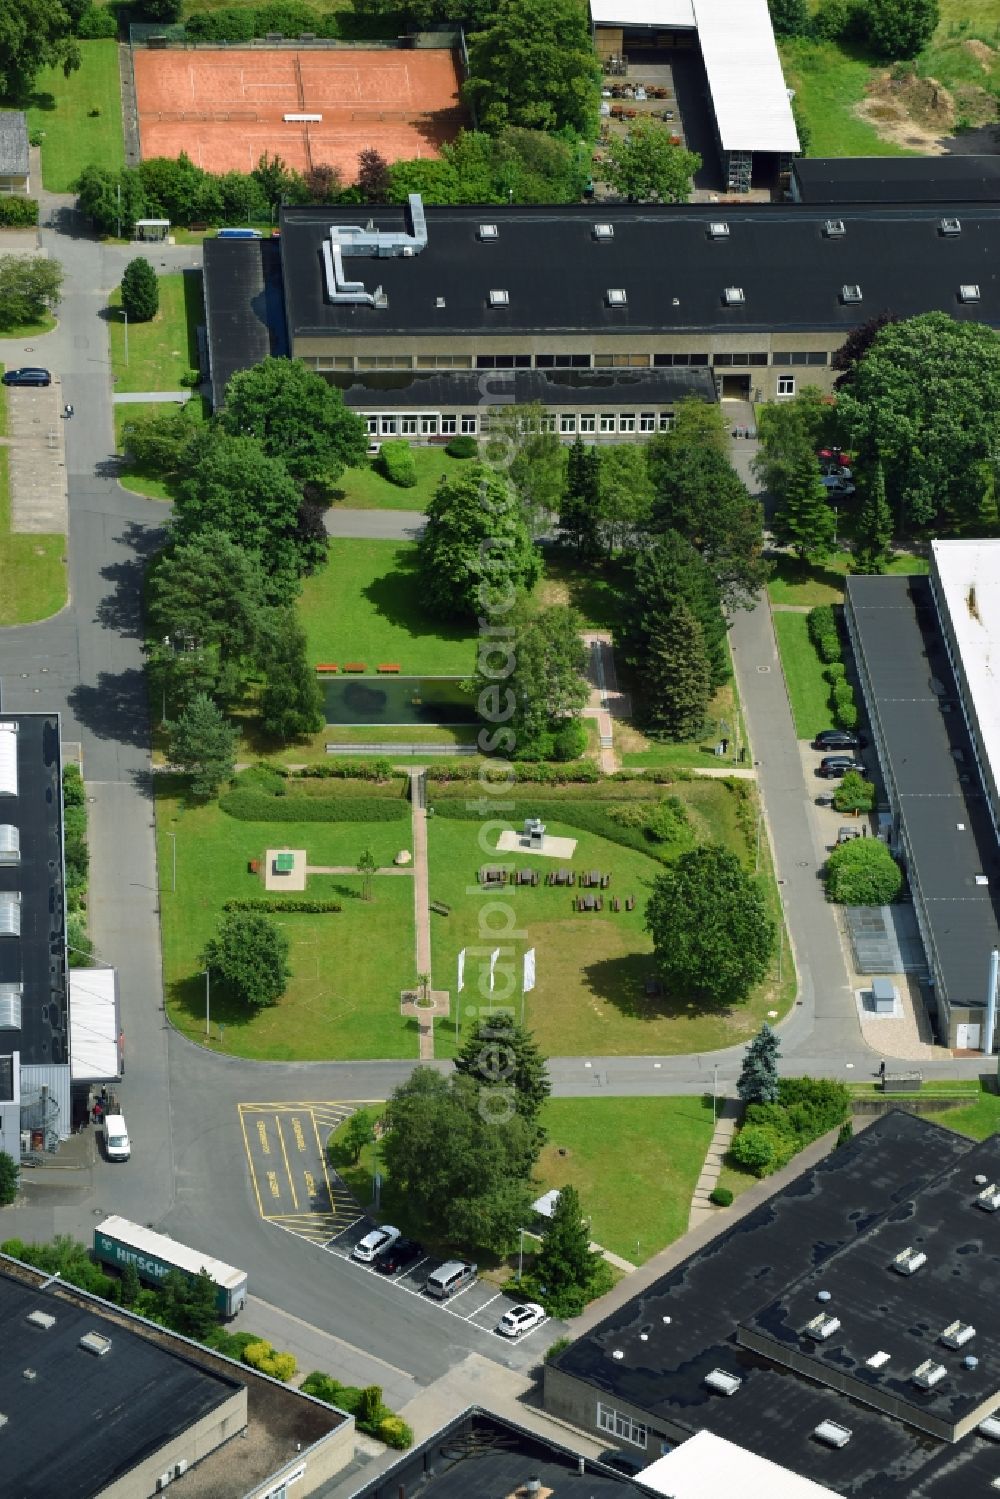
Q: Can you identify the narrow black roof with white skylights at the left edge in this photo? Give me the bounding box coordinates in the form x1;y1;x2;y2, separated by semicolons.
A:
0;714;69;1066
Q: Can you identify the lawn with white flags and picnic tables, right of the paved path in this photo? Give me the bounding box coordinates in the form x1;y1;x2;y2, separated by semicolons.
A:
427;779;795;1055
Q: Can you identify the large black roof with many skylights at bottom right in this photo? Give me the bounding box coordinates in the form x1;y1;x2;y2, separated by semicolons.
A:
555;1111;1000;1499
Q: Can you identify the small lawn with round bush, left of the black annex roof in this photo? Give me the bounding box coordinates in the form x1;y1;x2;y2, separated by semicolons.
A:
109;271;204;391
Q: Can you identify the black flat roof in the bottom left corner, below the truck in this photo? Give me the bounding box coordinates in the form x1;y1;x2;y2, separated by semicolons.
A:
0;1273;240;1499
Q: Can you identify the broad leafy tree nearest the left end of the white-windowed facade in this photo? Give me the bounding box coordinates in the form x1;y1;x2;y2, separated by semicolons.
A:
219;358;367;486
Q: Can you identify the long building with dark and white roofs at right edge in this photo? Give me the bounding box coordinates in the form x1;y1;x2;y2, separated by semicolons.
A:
846;541;1000;1051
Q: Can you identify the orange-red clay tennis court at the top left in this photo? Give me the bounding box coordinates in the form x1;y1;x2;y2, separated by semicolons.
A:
133;48;465;181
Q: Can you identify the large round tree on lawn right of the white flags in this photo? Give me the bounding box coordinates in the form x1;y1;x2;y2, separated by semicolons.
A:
646;844;775;1006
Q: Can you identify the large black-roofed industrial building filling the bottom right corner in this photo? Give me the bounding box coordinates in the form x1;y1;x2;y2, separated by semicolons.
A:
544;1111;1000;1499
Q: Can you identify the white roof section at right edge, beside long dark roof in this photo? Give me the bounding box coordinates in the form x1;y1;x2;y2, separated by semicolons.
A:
931;541;1000;809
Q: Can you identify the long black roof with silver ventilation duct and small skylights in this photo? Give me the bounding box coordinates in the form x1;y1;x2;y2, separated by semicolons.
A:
277;204;1000;340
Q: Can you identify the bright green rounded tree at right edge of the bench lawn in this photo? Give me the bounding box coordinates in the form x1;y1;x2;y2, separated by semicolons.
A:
417;463;541;619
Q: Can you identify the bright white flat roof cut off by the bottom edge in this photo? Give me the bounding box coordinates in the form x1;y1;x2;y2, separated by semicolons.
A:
639;1427;834;1499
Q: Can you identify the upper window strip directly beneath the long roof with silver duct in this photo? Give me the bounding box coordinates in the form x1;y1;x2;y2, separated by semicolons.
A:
313;351;829;370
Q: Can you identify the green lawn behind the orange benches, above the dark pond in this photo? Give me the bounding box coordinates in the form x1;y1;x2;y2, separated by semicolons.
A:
298;538;475;674
